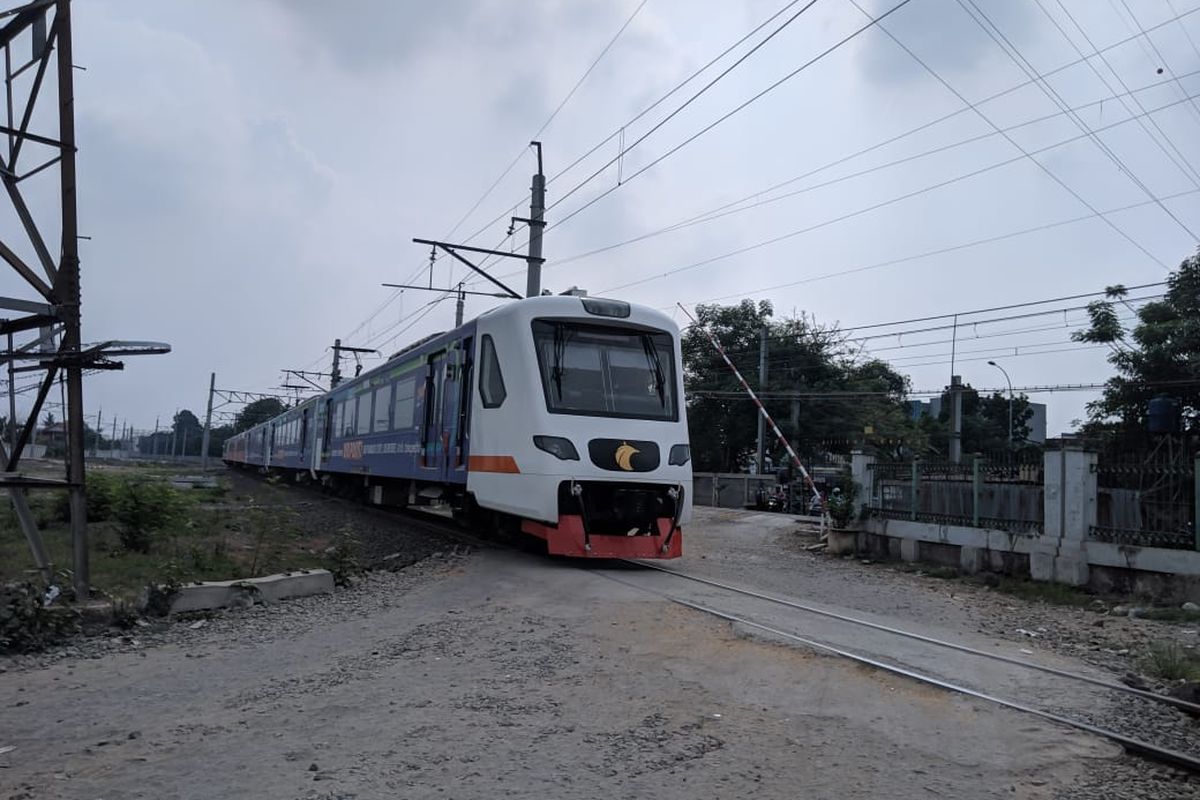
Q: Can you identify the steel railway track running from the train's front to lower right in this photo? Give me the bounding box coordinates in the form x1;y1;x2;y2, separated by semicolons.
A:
596;561;1200;775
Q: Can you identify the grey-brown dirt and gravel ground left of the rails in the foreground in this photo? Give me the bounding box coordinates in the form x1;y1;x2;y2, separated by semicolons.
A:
0;551;1115;800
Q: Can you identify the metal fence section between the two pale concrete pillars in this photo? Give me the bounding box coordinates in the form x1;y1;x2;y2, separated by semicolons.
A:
866;453;1045;536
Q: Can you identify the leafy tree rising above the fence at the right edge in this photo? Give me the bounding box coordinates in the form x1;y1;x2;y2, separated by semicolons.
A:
1072;249;1200;434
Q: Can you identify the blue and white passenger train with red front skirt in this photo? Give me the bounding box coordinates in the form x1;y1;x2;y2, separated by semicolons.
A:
223;294;692;559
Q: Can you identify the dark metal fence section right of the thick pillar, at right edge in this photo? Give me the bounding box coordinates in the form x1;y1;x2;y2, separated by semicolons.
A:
1090;438;1200;549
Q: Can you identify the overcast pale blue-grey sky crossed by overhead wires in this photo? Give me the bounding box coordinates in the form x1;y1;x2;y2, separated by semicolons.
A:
0;0;1200;435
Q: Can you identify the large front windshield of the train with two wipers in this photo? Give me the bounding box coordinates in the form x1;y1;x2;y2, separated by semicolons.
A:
533;320;679;420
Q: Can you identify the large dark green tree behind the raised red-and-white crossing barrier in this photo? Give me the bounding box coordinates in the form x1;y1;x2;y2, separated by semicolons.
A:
682;300;923;470
